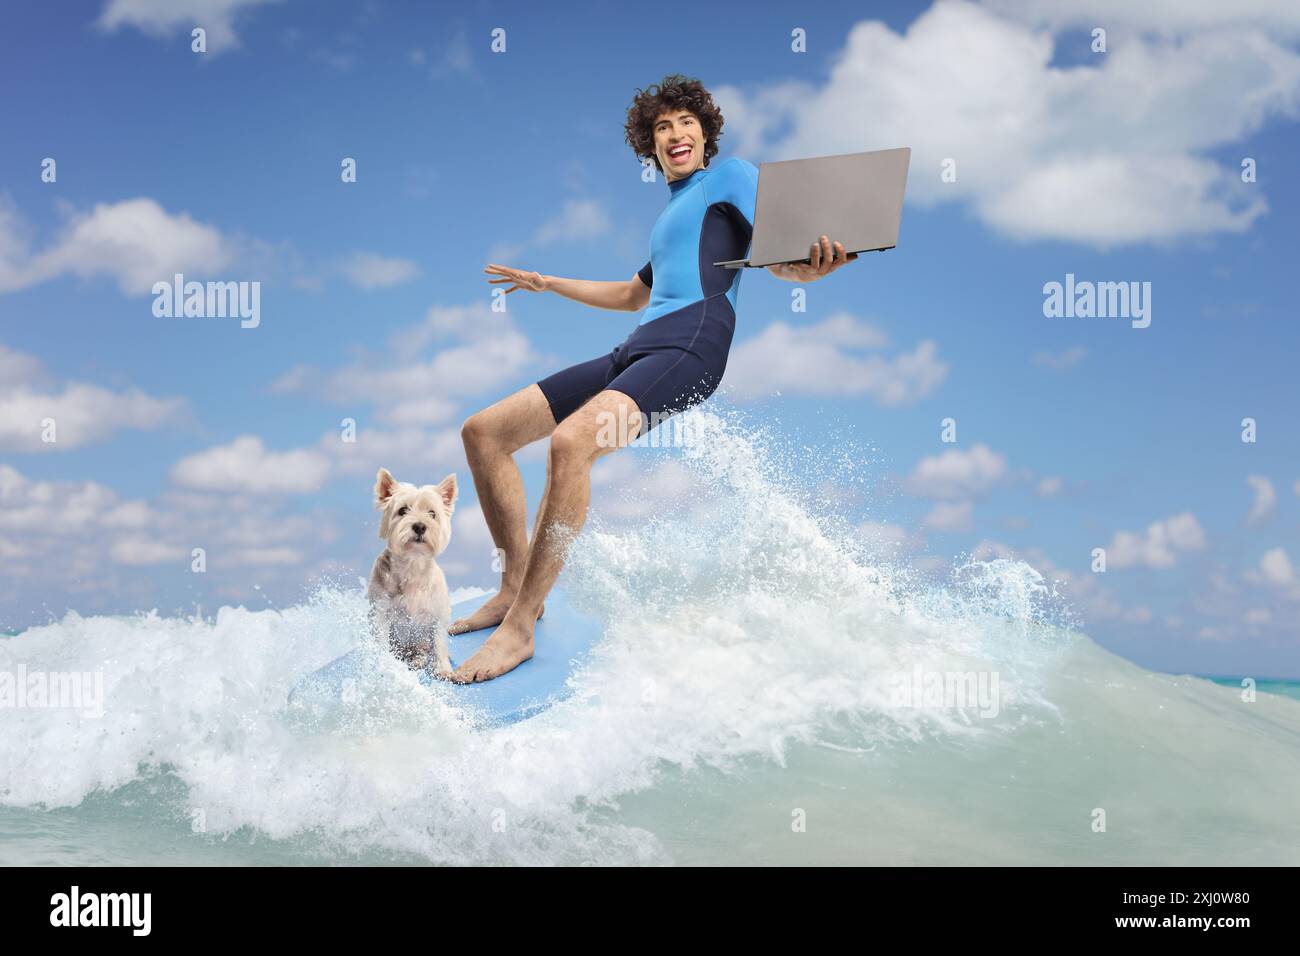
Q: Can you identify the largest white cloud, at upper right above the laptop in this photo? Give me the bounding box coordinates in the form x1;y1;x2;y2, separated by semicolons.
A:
715;0;1300;247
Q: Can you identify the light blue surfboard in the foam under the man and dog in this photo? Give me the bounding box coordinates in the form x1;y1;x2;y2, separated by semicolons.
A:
289;588;601;724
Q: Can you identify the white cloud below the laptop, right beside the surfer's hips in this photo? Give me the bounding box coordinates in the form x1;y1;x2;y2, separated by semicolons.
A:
723;312;948;406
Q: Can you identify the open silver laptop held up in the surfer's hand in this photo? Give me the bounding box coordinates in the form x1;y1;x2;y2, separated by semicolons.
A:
714;147;911;269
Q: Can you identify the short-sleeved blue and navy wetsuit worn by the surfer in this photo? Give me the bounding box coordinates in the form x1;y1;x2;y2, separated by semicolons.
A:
537;157;758;433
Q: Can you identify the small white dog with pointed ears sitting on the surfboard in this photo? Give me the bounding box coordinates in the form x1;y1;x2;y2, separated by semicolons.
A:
367;468;456;678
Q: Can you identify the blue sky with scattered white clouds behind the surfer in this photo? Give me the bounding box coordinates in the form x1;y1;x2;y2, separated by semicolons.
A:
0;0;1300;676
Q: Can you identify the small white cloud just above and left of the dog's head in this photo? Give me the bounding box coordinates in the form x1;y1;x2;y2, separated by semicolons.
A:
172;434;330;494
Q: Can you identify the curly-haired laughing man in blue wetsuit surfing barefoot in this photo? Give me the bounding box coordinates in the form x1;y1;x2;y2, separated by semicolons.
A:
451;74;857;683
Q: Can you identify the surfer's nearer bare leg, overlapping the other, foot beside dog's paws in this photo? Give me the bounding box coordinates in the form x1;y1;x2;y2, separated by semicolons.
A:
451;389;642;683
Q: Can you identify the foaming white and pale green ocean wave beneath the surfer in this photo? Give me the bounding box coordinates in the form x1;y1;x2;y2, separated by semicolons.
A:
0;410;1300;864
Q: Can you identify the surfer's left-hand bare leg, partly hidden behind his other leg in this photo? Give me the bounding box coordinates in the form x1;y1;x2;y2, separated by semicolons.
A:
450;382;555;633
